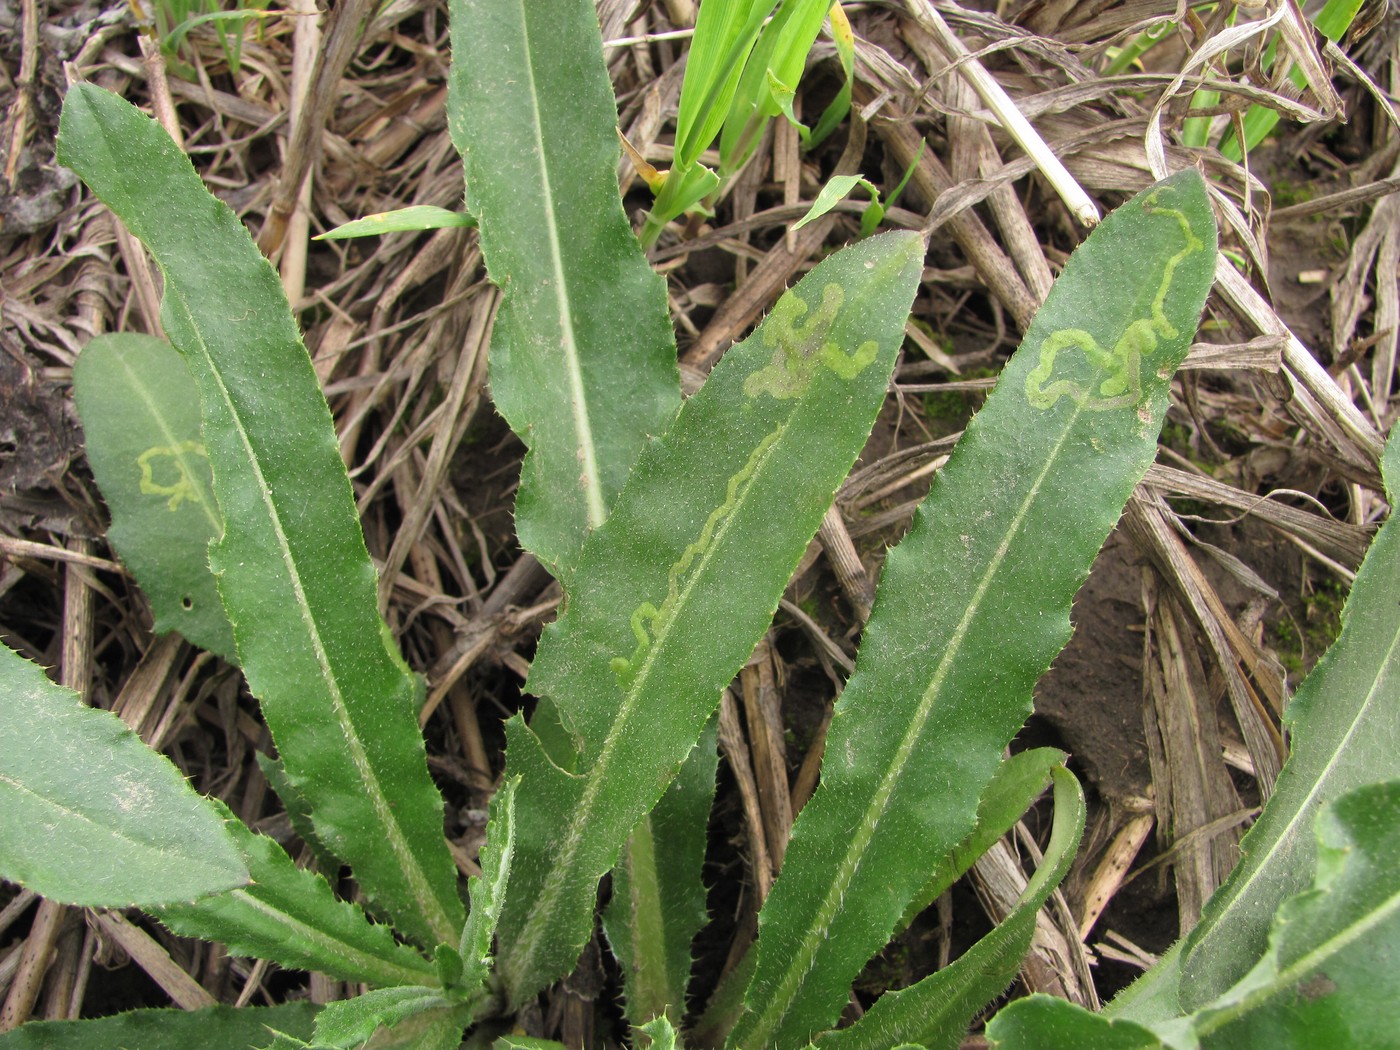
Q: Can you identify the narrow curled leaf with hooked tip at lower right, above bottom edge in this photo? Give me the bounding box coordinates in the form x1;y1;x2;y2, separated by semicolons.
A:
816;766;1084;1050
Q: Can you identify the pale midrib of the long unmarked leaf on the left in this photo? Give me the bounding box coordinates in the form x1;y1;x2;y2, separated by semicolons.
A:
167;296;452;941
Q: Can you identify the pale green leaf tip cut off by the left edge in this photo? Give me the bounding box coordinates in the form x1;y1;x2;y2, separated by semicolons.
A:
0;645;248;907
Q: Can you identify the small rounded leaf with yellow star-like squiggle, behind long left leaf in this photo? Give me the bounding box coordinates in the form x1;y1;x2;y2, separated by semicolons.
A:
73;335;238;664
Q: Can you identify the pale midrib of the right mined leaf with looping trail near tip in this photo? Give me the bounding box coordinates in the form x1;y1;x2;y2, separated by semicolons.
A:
746;406;1082;1046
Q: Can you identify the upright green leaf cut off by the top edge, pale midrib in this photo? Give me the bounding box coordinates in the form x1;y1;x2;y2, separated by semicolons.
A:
448;0;680;585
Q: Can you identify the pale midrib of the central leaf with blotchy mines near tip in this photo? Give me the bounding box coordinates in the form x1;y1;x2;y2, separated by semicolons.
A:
512;414;792;996
